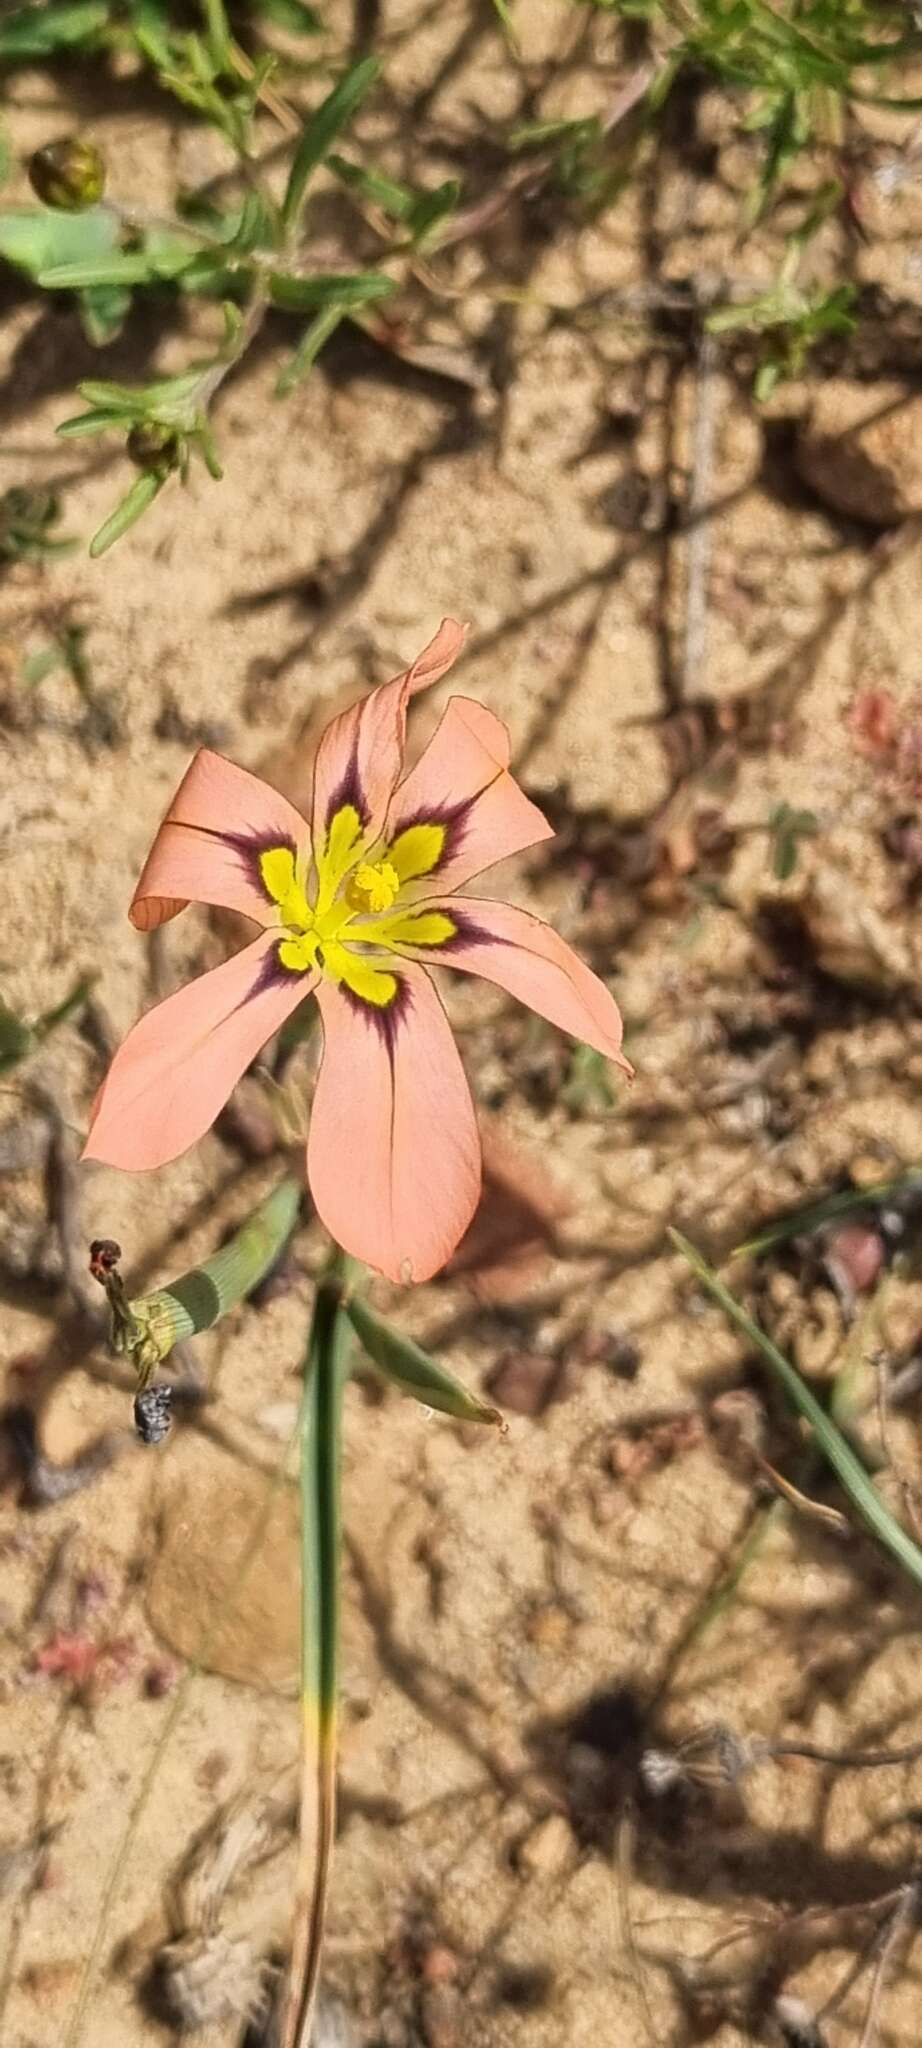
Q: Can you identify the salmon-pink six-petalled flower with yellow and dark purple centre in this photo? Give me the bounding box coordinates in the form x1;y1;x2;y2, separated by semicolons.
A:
84;618;631;1280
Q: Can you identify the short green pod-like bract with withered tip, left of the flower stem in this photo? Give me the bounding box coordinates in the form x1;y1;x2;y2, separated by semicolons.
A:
113;1178;301;1366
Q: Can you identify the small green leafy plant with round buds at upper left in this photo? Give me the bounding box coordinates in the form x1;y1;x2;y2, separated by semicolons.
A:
0;0;459;555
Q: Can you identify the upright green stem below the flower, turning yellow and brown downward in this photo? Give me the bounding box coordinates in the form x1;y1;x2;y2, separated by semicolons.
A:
281;1255;352;2048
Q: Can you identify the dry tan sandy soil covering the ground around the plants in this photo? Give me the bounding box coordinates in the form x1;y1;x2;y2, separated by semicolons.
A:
0;0;922;2048
